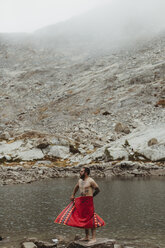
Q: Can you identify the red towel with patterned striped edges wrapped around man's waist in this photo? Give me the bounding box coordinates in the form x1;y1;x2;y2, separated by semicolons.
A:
54;196;105;228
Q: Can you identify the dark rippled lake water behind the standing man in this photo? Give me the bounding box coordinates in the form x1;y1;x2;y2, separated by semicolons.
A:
0;178;165;248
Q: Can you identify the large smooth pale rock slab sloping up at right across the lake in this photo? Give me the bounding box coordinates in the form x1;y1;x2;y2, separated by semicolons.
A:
102;125;165;162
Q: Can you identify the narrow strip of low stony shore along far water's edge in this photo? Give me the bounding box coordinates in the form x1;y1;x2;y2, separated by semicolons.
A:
0;161;165;185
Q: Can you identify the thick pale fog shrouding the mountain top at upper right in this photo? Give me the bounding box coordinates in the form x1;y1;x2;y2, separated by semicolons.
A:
0;0;165;51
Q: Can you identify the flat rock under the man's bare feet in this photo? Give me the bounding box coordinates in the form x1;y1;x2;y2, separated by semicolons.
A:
67;238;116;248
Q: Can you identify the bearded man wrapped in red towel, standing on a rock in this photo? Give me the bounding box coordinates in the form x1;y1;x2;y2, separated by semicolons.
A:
55;167;105;244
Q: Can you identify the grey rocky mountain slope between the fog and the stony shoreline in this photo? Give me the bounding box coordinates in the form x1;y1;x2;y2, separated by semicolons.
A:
0;20;165;182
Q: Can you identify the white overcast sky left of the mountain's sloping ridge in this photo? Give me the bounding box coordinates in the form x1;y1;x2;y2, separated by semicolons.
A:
0;0;111;32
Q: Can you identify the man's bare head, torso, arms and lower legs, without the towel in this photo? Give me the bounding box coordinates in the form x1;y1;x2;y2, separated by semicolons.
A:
71;167;100;244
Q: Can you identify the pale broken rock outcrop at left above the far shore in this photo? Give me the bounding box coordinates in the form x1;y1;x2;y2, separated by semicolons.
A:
0;138;69;162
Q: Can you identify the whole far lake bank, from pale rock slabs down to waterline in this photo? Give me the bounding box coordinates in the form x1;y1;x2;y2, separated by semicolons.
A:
0;125;165;185
